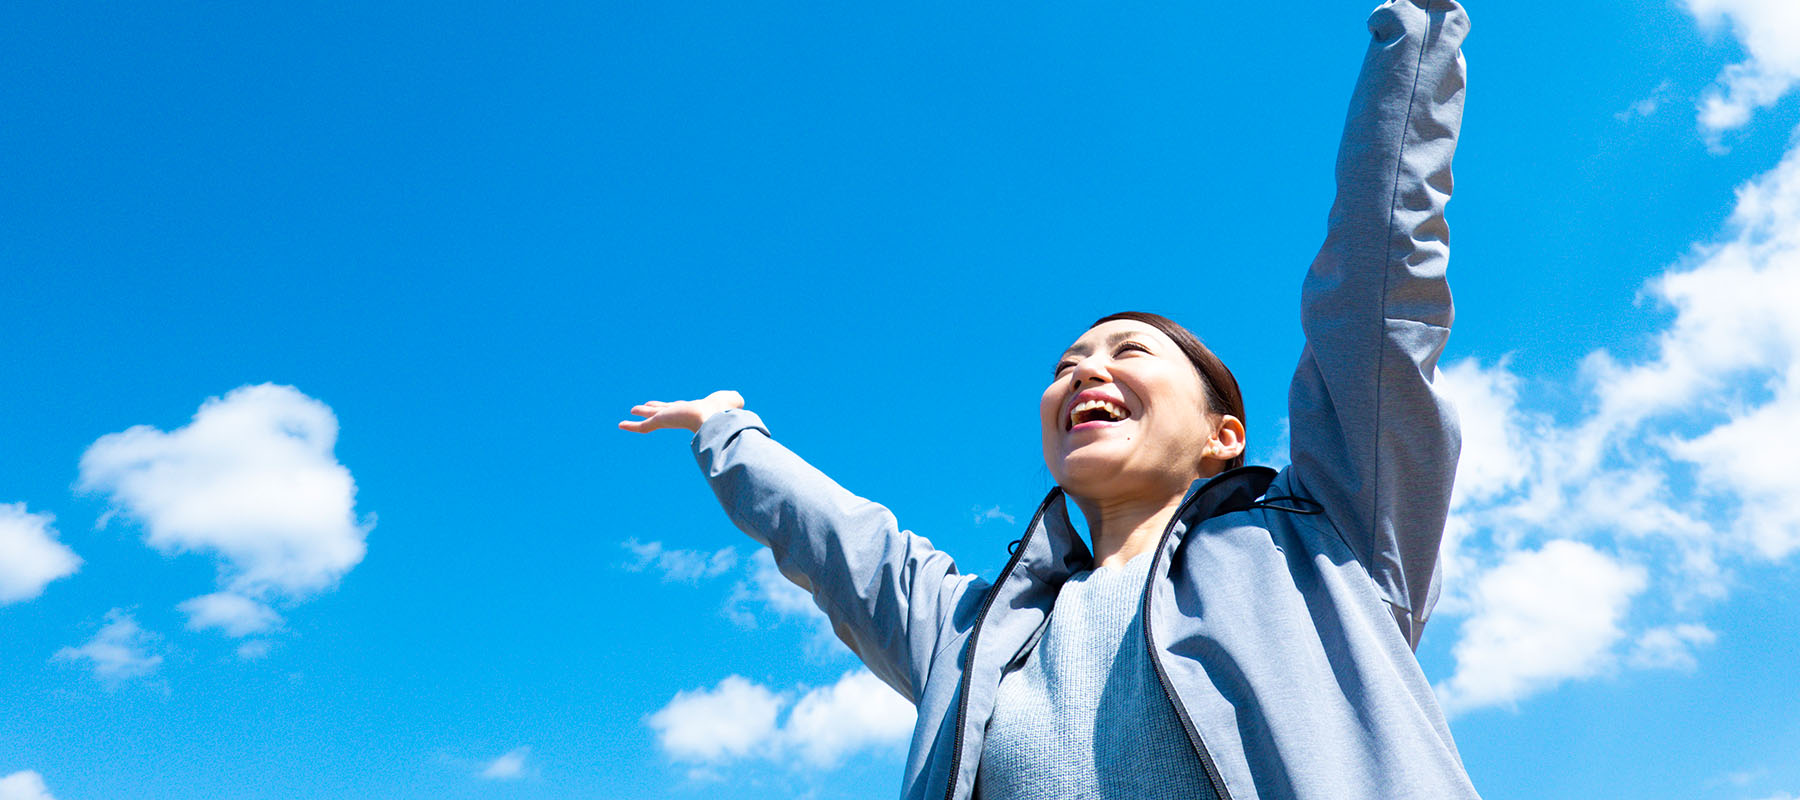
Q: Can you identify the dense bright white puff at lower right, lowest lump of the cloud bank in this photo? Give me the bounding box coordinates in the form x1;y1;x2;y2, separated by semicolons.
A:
1436;541;1645;714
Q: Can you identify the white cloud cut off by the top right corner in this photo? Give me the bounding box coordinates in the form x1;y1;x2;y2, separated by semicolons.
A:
1685;0;1800;135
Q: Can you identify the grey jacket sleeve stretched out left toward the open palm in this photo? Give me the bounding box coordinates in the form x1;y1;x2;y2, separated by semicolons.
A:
693;411;976;703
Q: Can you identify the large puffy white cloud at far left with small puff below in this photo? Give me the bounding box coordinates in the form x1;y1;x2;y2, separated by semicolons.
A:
79;384;371;636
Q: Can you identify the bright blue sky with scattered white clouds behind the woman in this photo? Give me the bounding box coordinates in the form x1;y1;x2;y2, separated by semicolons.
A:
0;0;1800;800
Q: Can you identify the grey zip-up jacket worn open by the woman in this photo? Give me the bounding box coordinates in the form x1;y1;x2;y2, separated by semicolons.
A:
693;0;1476;800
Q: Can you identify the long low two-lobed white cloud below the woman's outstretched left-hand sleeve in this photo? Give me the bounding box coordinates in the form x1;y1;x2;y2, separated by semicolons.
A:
646;668;918;768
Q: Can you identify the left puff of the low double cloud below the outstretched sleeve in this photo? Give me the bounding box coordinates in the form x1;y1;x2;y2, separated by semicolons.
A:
646;676;783;760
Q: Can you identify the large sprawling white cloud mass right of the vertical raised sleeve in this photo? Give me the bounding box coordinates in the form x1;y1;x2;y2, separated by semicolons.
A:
1438;129;1800;710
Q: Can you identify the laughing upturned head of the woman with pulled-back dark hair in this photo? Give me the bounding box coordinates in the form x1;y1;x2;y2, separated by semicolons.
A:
1039;319;1213;501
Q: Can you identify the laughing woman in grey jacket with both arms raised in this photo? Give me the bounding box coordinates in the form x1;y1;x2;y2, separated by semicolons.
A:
621;0;1474;800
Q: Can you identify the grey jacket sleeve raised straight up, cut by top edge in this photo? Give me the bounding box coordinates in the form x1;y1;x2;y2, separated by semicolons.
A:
1287;0;1469;647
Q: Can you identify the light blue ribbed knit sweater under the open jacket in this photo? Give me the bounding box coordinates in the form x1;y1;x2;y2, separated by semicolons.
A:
976;553;1217;800
